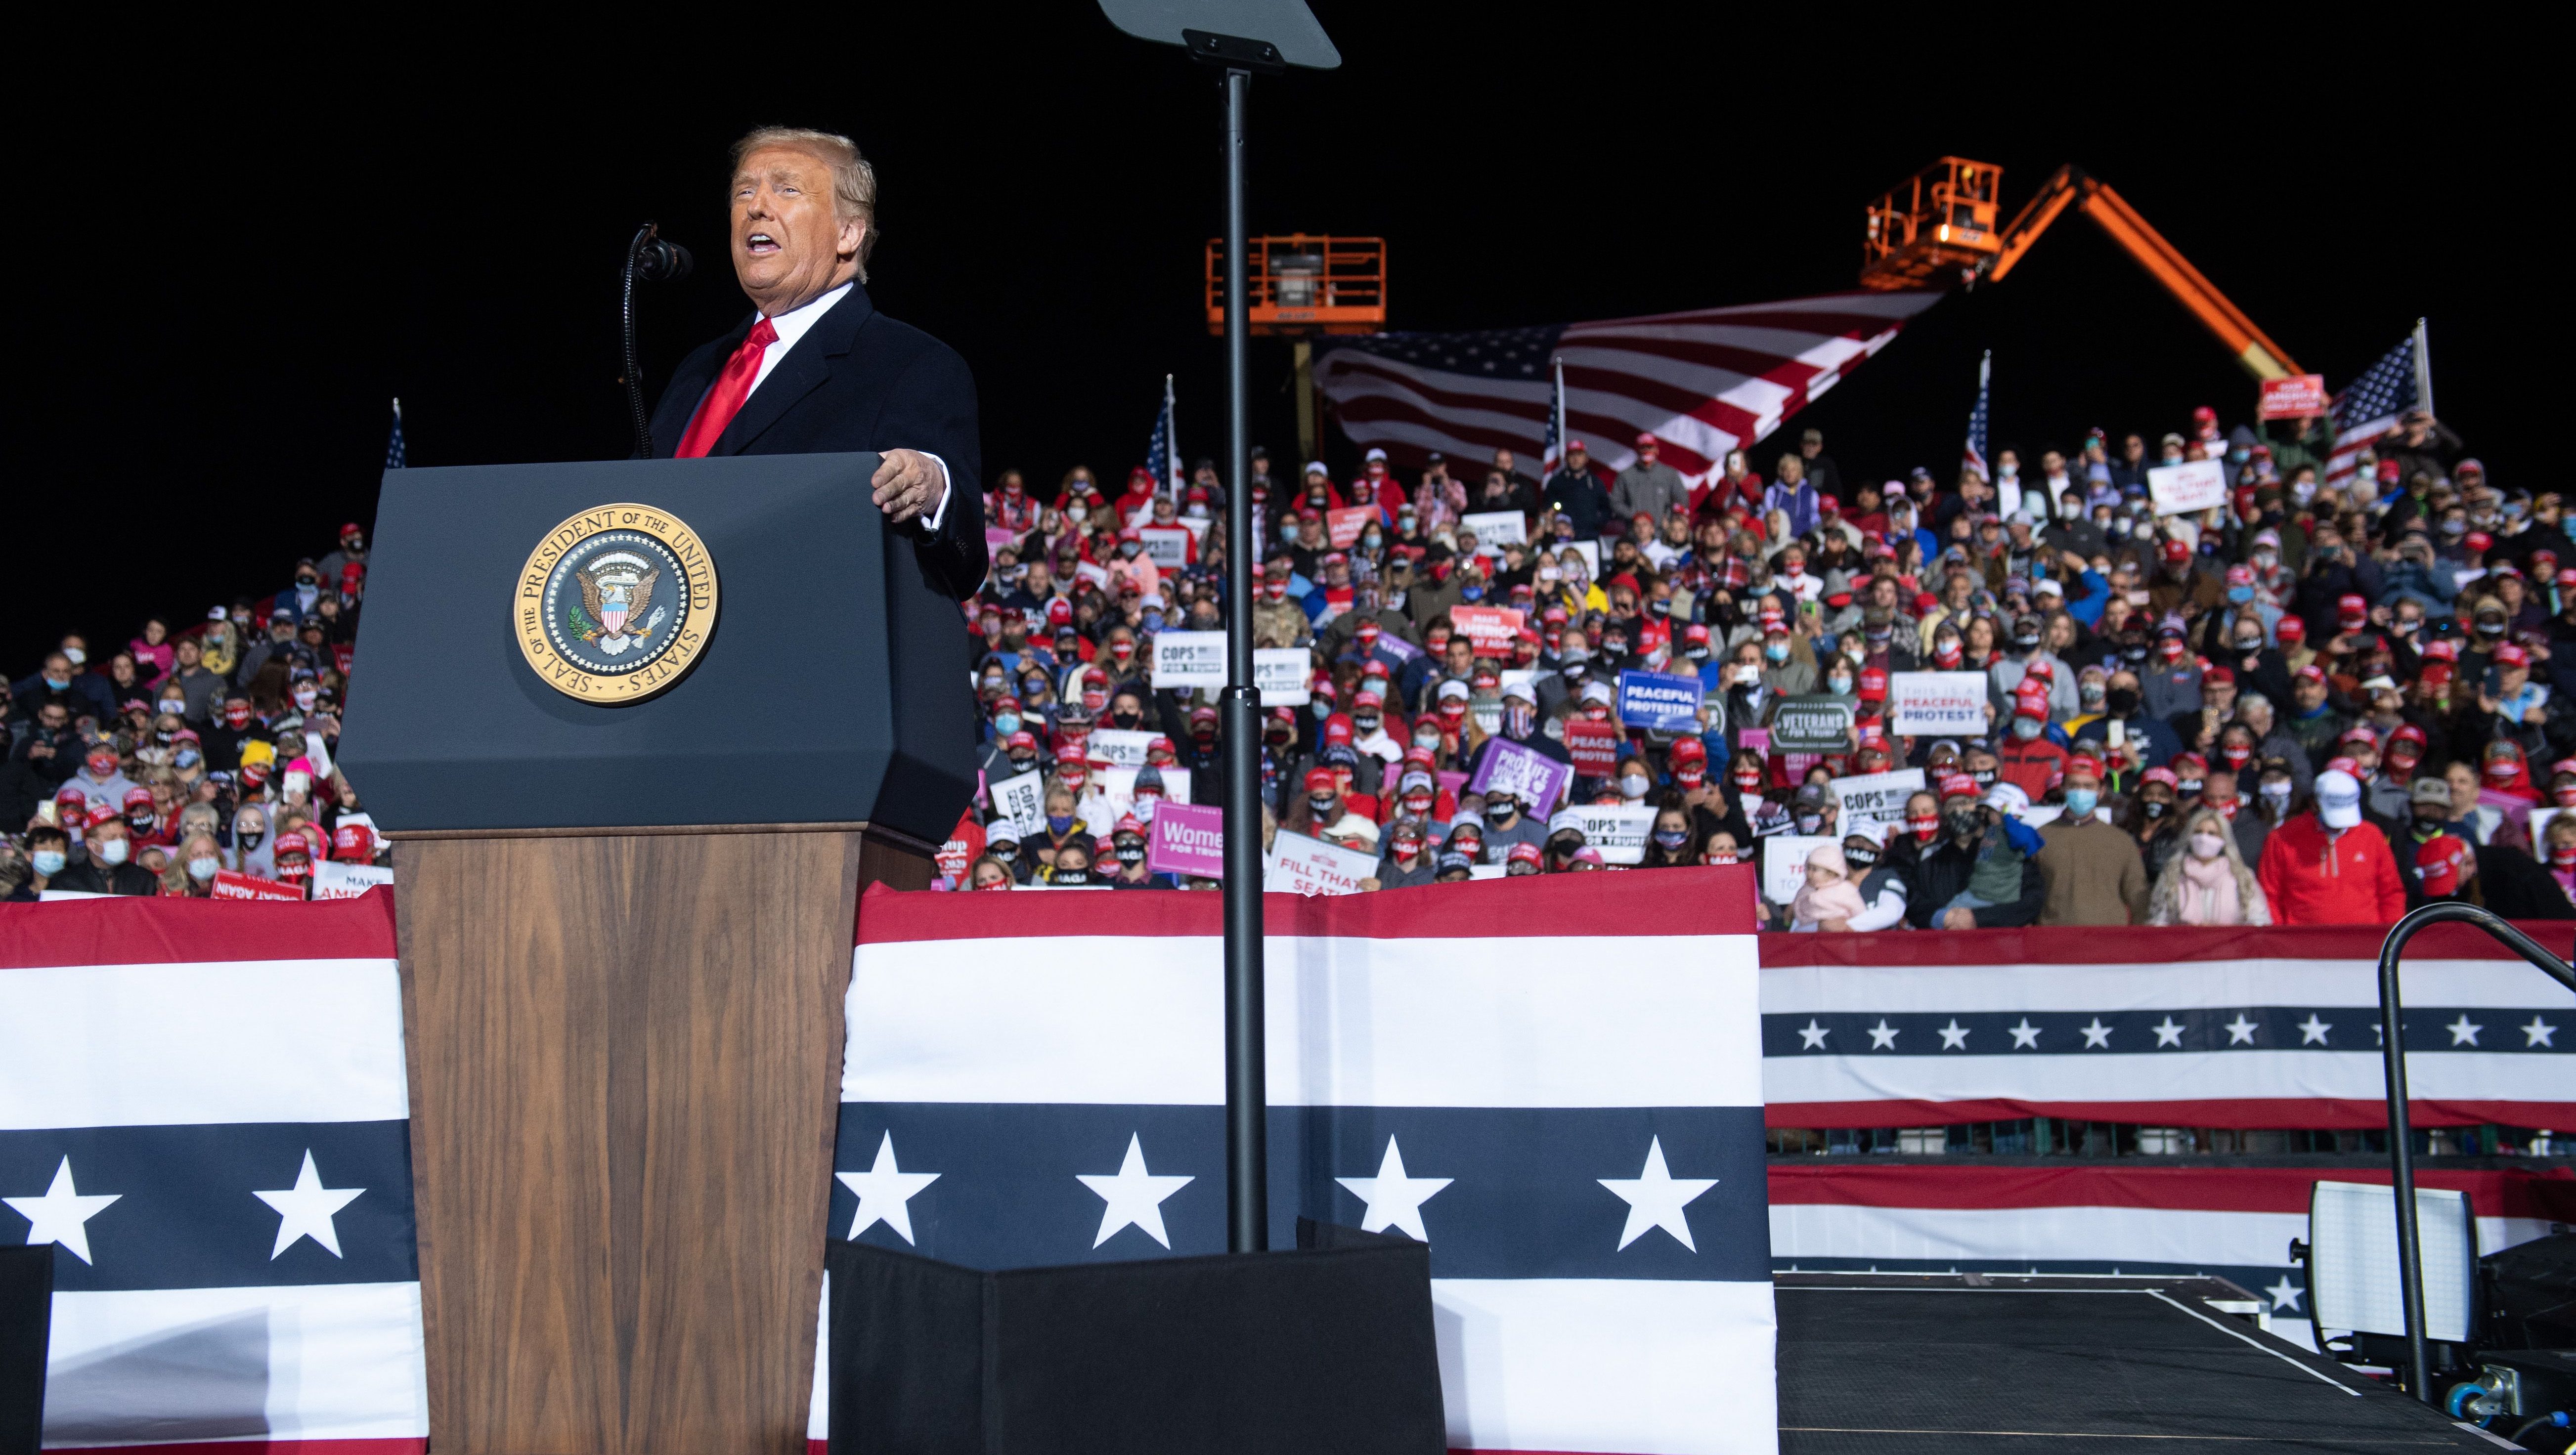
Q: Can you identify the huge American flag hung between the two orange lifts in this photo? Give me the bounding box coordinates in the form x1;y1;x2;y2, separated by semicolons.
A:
1314;294;1940;476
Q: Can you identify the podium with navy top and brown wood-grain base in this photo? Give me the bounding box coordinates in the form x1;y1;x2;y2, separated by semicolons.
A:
343;456;974;1455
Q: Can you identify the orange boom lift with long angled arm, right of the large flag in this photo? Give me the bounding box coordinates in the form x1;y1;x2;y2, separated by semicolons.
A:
1860;157;2303;379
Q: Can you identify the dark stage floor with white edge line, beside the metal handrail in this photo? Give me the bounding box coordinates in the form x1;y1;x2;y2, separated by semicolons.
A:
1772;1272;2504;1455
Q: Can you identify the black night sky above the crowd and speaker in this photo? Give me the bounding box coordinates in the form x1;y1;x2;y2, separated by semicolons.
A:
0;14;2534;677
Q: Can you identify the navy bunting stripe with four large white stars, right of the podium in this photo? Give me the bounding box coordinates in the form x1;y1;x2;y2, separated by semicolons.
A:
832;1102;1770;1280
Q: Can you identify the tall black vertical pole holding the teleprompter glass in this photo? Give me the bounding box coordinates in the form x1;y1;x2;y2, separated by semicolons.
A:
1221;70;1270;1254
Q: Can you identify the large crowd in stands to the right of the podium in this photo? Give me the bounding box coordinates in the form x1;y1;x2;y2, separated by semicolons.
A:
937;409;2576;932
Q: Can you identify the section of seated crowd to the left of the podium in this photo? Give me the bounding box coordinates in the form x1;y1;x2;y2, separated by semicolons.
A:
0;525;389;901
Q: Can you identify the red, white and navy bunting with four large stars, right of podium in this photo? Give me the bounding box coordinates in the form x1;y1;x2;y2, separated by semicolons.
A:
834;868;1778;1455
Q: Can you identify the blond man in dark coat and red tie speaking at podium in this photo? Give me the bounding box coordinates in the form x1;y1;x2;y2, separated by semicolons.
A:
652;126;987;600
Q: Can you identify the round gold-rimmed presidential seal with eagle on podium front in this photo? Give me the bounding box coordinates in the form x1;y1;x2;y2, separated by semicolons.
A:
510;505;716;706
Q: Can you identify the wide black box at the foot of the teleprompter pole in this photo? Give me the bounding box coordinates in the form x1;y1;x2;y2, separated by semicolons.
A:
825;1218;1448;1455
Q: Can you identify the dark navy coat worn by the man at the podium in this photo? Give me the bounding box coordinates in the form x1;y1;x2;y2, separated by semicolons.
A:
652;283;989;600
